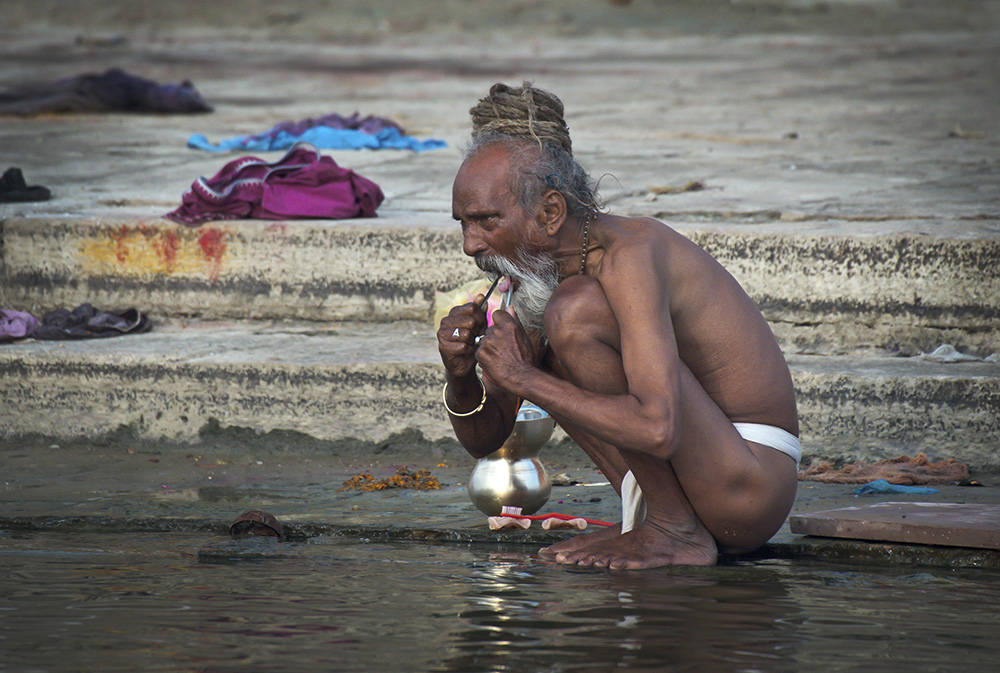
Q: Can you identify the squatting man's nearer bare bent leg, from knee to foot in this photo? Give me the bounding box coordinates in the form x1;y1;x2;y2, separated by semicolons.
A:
546;277;796;567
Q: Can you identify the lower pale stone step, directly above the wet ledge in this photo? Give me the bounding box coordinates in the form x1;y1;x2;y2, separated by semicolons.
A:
0;321;1000;471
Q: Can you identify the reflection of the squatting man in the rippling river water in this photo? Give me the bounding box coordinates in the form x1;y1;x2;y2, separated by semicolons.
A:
435;556;801;672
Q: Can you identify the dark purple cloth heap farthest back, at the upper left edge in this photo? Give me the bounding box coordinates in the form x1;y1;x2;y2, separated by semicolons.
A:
0;68;212;116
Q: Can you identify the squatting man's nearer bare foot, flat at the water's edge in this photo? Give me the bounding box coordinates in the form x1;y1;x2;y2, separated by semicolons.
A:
550;519;718;570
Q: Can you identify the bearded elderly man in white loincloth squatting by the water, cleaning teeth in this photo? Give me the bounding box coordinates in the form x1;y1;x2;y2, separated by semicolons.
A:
437;83;800;568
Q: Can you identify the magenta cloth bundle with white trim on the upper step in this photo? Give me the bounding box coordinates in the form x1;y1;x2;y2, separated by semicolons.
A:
164;143;385;226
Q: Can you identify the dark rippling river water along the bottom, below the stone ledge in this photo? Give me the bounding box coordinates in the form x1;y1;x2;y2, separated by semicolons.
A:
0;531;1000;673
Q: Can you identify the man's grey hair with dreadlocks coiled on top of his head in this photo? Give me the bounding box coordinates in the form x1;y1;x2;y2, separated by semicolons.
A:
465;82;600;217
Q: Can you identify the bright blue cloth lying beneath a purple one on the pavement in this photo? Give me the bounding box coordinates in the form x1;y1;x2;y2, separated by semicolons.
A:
188;126;447;152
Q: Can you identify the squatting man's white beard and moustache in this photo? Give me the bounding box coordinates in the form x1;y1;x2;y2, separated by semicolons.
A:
476;248;560;337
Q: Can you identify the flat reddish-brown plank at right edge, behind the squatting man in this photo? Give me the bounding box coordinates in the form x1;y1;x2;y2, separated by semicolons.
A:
788;502;1000;550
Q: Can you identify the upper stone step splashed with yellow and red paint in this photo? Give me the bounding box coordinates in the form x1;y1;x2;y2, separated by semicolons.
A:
0;217;1000;355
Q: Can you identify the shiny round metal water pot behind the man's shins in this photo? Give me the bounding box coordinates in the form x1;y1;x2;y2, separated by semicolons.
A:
469;402;555;516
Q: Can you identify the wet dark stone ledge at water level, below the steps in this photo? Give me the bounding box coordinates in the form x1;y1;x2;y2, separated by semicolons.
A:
0;443;1000;567
